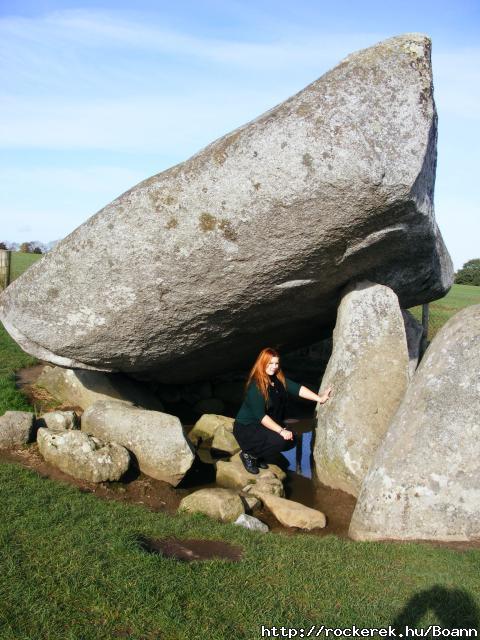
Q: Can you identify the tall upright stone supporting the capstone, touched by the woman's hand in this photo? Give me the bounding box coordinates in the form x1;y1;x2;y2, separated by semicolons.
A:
313;281;409;496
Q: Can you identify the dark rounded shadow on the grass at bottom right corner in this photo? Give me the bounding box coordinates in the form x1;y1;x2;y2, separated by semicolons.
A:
392;585;479;635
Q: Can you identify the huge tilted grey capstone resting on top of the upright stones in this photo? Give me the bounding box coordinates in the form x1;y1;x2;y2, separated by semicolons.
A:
0;34;452;383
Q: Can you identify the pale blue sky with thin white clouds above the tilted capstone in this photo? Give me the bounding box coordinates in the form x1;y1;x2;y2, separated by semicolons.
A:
0;0;480;268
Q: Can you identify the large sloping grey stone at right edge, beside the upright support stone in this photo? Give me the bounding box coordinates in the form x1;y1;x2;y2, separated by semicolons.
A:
350;305;480;540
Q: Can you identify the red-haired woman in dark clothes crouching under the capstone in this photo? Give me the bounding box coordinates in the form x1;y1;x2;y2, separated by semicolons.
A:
233;348;331;474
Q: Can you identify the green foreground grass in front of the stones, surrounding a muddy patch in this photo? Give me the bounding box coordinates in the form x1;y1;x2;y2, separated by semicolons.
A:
0;464;480;640
